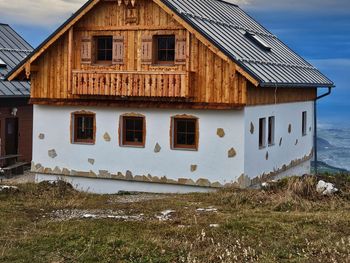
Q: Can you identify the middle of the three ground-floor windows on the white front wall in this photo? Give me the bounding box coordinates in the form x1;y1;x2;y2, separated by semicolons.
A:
122;116;146;147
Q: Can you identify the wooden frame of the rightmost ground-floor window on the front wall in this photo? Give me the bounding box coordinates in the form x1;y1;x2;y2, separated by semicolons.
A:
170;115;199;151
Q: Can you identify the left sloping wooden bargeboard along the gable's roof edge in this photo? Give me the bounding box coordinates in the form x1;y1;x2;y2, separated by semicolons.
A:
8;0;101;81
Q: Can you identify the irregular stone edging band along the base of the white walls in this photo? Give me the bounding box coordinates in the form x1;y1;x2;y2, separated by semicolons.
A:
31;149;313;188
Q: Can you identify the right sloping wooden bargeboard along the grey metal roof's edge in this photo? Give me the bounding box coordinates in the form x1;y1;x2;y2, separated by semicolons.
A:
153;0;259;87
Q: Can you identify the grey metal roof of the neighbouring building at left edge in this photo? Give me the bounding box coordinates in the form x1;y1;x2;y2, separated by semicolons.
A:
0;24;33;98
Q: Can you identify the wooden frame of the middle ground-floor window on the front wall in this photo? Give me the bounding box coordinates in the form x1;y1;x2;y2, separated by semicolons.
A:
119;113;147;148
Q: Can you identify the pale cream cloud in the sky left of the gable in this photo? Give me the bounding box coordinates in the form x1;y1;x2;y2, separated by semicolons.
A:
0;0;86;27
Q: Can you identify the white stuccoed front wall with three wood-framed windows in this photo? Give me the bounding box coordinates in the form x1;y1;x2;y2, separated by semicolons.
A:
33;105;244;187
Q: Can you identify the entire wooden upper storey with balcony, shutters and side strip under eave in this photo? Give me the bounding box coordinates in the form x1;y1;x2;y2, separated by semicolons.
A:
10;0;316;109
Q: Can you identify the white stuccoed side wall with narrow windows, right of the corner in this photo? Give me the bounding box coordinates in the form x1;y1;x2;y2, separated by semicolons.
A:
244;101;314;178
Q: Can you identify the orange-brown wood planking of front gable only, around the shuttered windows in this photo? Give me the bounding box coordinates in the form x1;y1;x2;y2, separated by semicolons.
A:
31;0;247;105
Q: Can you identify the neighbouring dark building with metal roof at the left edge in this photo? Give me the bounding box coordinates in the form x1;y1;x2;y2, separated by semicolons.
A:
0;24;33;162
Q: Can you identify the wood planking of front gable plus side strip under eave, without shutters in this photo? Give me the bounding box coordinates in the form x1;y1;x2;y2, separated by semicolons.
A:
31;0;315;108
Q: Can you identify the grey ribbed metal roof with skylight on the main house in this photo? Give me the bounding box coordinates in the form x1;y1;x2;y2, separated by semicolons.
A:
162;0;334;87
